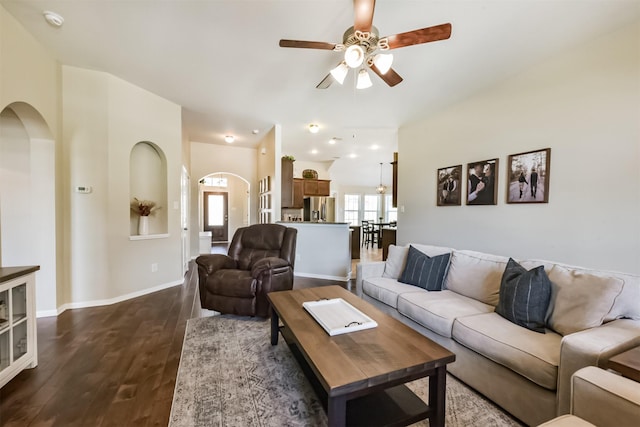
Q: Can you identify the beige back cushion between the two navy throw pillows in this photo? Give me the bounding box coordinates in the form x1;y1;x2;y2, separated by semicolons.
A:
444;250;509;306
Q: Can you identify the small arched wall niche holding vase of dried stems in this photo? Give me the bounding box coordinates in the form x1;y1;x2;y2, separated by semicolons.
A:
129;141;169;238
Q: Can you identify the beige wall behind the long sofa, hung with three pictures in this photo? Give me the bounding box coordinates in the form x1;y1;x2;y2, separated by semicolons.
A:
398;23;640;273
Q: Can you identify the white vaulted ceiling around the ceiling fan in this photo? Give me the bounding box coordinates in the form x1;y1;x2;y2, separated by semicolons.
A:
0;0;640;185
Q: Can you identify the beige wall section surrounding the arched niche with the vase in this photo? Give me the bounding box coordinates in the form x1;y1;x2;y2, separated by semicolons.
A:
62;66;182;307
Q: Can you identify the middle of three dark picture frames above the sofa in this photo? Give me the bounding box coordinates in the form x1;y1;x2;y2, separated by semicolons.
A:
467;158;499;206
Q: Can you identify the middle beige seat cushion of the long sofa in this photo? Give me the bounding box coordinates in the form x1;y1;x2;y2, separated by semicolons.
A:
398;290;493;338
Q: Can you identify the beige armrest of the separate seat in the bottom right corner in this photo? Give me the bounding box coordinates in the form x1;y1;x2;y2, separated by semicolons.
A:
571;366;640;427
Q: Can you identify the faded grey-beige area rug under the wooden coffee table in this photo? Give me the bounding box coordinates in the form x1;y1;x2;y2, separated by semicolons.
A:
169;315;521;427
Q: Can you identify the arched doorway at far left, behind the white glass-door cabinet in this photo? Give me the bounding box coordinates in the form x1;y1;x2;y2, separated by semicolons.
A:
0;102;57;316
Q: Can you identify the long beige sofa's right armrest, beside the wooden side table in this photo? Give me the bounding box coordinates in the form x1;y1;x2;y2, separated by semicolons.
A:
557;319;640;415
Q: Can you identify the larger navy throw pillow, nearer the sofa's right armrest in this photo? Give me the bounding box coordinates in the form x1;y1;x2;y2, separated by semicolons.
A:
496;258;551;334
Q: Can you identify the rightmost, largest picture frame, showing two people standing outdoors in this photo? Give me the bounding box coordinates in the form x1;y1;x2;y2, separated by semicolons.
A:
507;148;551;203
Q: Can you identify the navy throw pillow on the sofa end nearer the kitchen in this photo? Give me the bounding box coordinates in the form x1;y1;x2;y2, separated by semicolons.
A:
398;246;451;291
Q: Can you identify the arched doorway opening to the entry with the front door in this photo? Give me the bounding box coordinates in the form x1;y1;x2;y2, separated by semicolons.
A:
198;172;251;247
